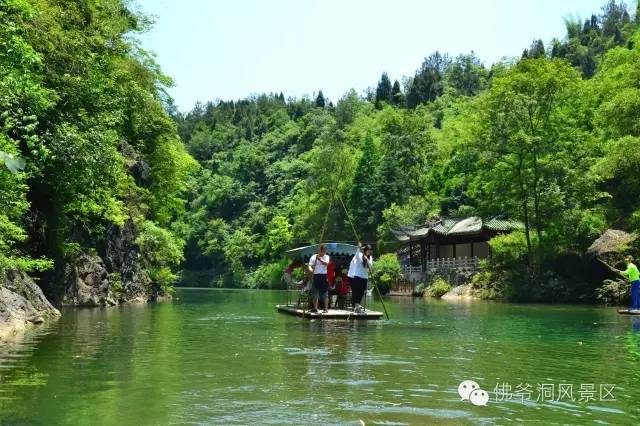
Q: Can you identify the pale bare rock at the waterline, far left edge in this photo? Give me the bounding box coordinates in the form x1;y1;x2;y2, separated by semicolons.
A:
0;270;60;339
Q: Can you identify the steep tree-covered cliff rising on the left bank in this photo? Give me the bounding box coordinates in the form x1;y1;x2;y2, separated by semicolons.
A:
0;0;198;304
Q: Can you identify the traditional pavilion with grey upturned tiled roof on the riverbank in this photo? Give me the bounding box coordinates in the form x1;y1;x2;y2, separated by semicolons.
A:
393;216;522;278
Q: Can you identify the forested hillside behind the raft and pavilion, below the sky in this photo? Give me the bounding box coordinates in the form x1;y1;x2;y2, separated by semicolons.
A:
176;1;640;300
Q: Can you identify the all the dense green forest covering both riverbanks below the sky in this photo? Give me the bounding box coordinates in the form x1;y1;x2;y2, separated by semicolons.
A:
0;0;640;301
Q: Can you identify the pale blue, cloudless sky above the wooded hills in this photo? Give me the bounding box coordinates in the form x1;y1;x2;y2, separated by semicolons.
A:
136;0;605;111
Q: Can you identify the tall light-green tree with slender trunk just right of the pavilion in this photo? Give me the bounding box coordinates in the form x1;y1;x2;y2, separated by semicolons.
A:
472;58;585;276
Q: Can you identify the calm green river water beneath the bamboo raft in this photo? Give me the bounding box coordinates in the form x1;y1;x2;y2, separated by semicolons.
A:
0;289;640;425
